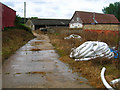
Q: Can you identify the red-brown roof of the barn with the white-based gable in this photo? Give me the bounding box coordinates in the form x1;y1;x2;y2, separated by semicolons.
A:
75;11;120;24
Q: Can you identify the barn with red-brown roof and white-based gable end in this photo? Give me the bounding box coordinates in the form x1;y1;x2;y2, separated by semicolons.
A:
69;11;120;31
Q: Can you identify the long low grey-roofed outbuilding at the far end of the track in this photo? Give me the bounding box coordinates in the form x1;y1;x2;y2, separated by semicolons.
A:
26;19;70;30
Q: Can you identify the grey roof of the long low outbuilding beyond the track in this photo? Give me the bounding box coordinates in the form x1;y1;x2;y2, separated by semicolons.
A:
30;19;70;25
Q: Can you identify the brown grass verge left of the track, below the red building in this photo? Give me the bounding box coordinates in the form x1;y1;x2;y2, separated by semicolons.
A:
2;29;34;63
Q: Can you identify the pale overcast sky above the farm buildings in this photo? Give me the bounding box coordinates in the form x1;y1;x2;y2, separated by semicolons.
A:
1;0;120;19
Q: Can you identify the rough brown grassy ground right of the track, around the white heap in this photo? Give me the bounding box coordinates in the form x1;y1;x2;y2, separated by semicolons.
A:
38;28;120;88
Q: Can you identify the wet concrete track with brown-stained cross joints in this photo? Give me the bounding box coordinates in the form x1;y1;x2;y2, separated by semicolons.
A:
2;35;92;88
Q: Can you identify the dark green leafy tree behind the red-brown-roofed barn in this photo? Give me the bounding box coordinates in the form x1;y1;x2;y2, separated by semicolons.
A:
102;2;120;21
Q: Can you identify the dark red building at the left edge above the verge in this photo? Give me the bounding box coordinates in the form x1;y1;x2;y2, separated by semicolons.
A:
0;2;16;30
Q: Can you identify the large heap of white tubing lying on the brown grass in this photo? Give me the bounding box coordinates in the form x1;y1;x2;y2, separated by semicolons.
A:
70;41;114;61
